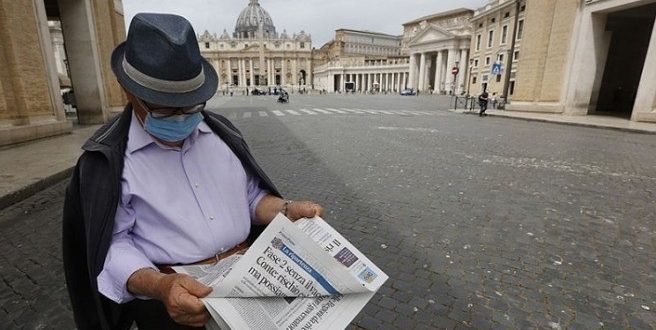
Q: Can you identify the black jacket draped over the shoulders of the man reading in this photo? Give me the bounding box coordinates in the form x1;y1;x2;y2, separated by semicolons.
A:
62;105;280;330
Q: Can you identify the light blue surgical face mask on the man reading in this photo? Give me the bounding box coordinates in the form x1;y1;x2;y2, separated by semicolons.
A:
144;112;203;142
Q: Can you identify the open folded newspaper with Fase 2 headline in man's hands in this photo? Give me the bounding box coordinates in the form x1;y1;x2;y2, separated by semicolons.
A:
174;214;388;330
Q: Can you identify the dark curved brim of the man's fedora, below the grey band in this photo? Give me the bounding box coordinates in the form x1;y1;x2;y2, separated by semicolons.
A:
112;42;219;107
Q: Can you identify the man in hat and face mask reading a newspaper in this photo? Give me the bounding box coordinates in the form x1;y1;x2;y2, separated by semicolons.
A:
63;13;323;329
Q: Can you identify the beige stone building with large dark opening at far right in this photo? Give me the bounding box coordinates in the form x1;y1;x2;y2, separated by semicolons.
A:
509;0;656;122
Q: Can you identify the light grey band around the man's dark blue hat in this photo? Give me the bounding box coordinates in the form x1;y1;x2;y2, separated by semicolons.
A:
122;57;205;93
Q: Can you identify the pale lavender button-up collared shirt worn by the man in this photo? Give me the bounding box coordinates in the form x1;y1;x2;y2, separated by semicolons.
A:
98;115;267;303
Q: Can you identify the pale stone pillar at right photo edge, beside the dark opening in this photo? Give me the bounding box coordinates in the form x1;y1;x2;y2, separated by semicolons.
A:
631;15;656;122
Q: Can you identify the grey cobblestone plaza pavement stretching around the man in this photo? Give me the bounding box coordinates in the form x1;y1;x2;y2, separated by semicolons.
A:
0;94;656;329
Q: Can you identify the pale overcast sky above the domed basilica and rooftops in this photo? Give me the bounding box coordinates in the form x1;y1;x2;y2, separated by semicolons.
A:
123;0;487;48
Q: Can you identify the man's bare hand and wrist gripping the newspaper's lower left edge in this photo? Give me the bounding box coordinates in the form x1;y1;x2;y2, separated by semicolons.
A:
128;268;212;327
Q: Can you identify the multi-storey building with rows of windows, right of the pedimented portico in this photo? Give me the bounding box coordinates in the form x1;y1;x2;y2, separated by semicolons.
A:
467;0;526;99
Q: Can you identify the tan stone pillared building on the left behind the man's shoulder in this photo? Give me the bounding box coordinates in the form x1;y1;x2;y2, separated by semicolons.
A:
0;0;125;145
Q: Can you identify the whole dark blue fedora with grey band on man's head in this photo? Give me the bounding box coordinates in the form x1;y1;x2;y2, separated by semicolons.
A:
112;13;218;107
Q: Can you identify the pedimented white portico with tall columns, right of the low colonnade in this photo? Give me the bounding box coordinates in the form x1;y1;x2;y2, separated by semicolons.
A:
402;8;474;94
